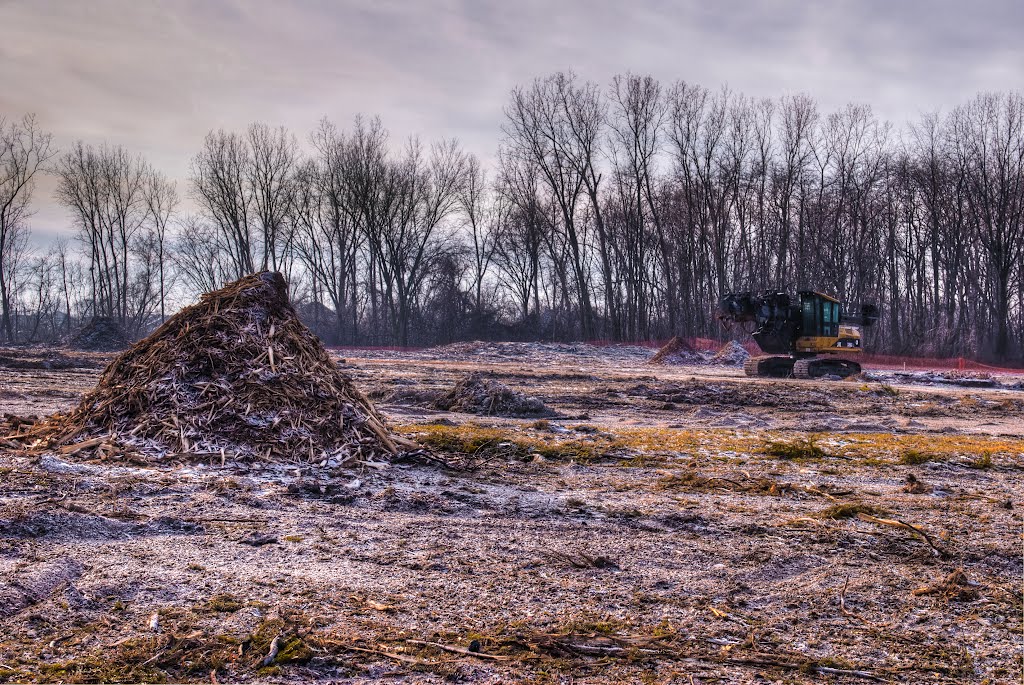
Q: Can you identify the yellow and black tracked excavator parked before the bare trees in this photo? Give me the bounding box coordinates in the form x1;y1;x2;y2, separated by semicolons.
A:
717;290;879;378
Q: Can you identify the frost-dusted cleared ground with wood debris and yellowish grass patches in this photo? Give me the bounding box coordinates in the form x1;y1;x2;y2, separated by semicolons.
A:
0;344;1024;683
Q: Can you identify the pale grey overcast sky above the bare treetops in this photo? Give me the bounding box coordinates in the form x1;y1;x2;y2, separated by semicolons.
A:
0;0;1024;237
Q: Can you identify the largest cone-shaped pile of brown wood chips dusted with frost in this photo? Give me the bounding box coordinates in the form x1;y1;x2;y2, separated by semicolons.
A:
29;271;397;464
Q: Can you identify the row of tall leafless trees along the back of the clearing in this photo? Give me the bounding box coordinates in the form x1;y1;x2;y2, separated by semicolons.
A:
0;73;1024;361
